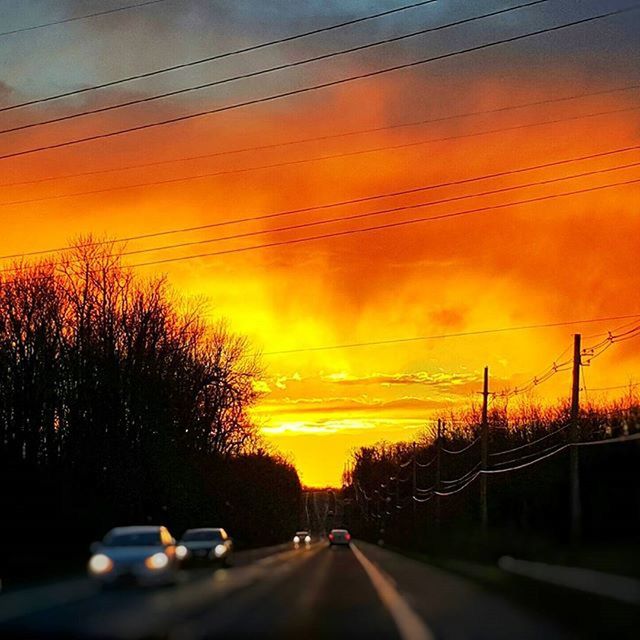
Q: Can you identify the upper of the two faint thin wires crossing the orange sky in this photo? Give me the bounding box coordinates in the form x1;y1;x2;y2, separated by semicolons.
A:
0;84;640;187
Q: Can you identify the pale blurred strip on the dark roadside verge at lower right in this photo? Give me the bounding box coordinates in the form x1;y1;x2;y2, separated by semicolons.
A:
498;556;640;604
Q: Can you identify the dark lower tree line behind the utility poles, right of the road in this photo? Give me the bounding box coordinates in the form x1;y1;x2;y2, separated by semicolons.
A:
343;398;640;569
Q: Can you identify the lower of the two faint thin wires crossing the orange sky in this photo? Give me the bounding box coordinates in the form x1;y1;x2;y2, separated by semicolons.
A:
0;107;639;207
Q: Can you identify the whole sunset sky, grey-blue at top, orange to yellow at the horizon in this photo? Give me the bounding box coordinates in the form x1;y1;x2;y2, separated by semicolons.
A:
0;0;640;485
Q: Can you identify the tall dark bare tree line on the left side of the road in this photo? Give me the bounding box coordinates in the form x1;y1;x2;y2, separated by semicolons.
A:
0;238;301;577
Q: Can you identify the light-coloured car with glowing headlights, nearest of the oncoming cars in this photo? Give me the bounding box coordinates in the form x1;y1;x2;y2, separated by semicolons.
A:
88;526;179;586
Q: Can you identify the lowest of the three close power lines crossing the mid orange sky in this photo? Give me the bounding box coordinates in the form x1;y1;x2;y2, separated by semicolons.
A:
129;178;640;267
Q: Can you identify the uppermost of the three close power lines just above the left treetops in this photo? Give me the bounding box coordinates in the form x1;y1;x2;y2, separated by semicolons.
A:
0;145;640;260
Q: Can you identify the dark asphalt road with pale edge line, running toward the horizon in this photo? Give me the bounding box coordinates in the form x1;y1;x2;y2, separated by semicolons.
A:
0;542;568;640
